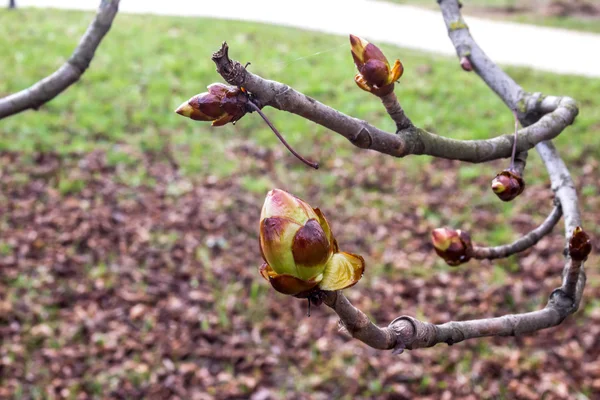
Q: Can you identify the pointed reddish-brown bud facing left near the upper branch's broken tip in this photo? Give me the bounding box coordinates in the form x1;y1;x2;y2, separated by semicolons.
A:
175;83;248;126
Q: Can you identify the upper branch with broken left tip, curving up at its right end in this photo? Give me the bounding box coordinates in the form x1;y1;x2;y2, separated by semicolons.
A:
212;43;578;162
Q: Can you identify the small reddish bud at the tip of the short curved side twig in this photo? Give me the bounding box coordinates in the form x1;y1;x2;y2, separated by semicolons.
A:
431;228;473;266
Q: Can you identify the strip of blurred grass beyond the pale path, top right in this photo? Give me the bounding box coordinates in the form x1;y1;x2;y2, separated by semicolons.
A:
385;0;600;33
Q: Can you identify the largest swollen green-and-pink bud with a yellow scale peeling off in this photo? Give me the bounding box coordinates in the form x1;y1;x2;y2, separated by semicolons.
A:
260;189;364;297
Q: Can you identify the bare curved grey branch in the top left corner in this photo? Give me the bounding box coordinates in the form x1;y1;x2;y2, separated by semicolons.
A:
0;0;119;119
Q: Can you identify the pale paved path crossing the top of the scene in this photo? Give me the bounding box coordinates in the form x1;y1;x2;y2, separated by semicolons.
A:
17;0;600;77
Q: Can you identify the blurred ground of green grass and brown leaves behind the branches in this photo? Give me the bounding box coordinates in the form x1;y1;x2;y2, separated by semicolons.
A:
0;0;600;400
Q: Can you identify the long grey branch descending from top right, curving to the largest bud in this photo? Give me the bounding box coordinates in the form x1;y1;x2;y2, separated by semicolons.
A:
318;0;586;349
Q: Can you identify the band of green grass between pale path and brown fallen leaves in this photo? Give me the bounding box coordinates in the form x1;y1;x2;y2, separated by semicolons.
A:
0;10;600;183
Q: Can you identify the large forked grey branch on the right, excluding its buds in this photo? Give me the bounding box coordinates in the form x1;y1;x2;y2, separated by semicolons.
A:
207;0;585;351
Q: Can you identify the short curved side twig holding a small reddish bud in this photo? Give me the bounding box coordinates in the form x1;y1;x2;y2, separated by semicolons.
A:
472;206;562;260
